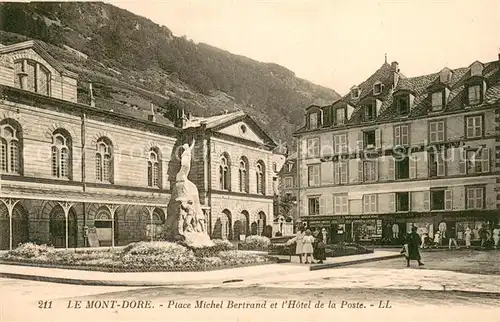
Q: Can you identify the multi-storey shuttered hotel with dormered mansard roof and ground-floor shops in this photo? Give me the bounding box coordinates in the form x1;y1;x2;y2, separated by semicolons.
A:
295;57;500;243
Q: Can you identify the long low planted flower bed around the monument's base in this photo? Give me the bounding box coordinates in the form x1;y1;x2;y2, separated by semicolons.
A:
1;241;273;272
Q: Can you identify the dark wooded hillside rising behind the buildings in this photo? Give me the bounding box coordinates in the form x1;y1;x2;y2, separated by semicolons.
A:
0;2;339;143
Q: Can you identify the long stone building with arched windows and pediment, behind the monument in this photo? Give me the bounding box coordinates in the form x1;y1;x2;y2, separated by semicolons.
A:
0;41;275;249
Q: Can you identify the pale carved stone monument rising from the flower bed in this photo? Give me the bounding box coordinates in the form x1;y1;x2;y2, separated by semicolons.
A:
167;140;214;248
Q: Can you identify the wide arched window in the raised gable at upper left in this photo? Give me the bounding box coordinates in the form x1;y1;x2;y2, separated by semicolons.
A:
14;59;50;95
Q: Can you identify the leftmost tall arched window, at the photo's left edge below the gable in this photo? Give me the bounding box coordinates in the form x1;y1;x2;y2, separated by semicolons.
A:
0;119;22;174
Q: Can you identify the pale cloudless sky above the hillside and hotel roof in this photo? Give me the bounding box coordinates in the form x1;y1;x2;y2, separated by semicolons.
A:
106;0;500;94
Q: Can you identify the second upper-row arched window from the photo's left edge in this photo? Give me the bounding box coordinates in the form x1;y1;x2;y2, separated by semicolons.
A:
51;129;71;179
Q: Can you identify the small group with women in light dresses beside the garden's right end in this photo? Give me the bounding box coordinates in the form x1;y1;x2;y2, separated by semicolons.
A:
287;227;328;264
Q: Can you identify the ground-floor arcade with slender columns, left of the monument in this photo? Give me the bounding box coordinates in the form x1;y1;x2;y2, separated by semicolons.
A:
0;197;167;250
